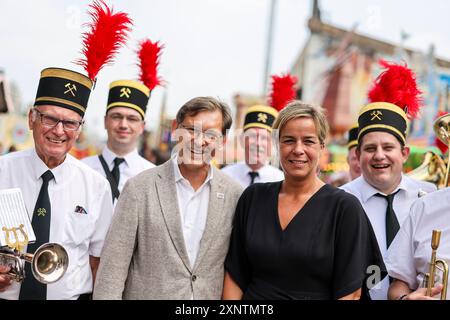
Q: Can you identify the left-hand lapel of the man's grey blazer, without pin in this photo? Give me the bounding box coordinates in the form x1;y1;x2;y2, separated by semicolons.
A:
156;160;192;271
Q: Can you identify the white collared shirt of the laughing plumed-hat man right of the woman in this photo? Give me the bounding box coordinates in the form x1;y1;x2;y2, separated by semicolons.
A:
341;175;436;300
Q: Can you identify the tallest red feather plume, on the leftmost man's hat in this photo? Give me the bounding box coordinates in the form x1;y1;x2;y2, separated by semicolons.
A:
76;0;133;81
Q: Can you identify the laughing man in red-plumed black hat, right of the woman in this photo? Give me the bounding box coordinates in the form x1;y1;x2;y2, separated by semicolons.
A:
342;61;436;300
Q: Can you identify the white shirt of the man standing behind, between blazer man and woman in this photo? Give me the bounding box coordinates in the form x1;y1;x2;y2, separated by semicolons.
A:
222;162;284;188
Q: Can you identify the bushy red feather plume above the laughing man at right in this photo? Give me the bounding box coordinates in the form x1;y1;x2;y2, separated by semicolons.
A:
369;60;423;118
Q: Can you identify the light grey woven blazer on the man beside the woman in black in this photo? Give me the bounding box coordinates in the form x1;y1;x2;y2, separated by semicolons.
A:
94;160;242;299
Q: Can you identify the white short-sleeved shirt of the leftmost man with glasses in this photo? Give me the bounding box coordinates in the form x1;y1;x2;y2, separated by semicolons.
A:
0;149;113;300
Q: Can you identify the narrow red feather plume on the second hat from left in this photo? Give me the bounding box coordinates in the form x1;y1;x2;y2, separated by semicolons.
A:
138;39;164;90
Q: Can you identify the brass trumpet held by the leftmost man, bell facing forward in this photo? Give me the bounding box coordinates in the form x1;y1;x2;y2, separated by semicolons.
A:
0;243;69;284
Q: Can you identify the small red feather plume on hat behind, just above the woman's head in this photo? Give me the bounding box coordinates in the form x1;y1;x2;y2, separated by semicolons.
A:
269;74;297;111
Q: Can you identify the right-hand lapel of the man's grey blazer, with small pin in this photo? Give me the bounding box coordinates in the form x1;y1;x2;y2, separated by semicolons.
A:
193;167;226;270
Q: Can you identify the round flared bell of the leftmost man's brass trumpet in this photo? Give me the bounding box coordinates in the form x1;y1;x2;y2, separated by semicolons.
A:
31;243;69;284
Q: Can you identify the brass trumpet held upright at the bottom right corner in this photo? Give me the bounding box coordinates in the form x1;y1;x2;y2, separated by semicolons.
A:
425;230;448;300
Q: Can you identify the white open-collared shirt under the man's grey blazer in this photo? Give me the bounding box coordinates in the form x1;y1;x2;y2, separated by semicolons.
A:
172;157;213;267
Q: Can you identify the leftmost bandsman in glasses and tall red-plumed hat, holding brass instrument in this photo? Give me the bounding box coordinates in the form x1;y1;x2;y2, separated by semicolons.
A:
0;1;132;300
